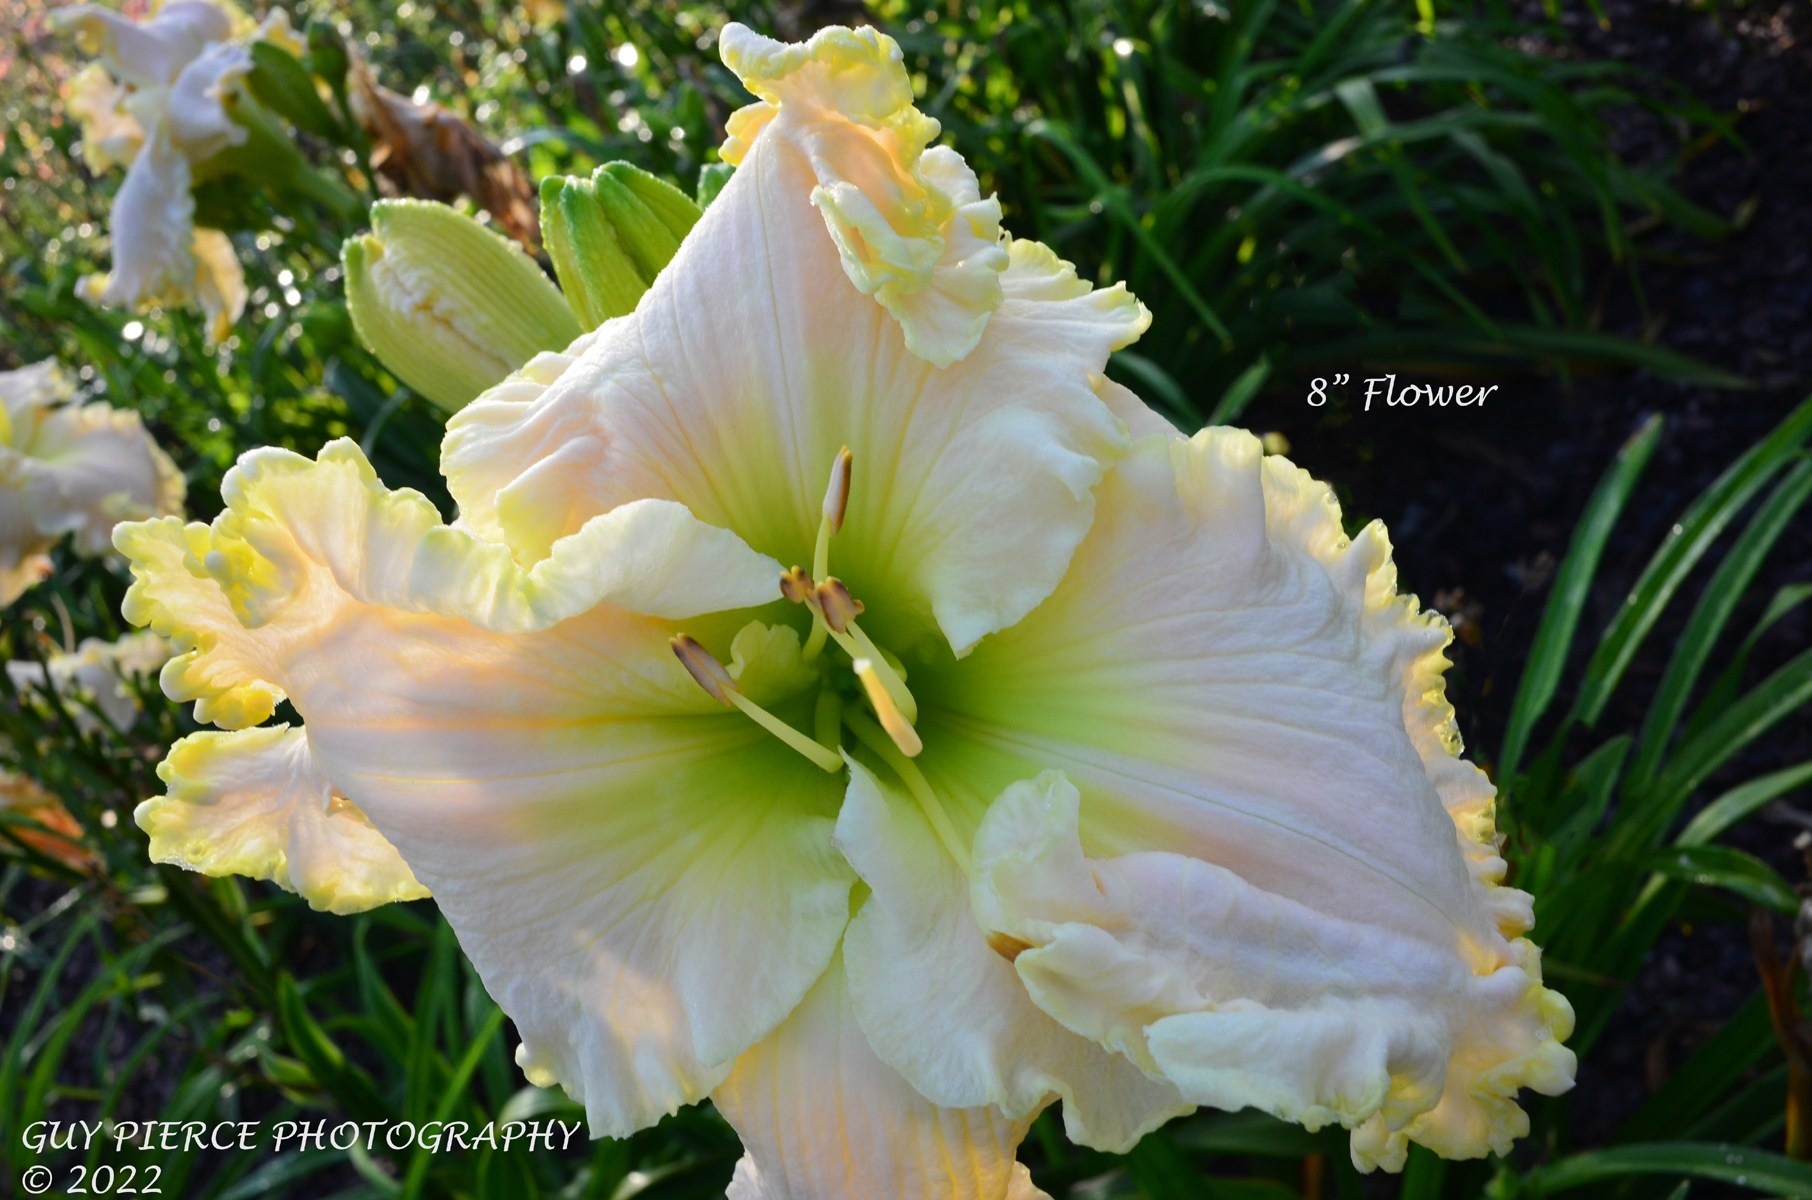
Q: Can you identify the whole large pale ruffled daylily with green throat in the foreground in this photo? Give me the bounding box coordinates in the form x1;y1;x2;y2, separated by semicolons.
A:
118;25;1573;1200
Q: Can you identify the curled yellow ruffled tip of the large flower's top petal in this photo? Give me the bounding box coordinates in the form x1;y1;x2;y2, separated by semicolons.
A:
719;22;1007;366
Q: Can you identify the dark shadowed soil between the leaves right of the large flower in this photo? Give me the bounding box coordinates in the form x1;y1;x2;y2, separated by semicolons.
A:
1247;0;1812;1144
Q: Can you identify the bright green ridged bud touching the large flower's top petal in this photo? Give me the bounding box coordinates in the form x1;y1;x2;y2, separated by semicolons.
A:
542;163;699;330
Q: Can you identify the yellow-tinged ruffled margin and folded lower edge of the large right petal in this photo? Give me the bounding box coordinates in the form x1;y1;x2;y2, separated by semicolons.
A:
973;430;1575;1171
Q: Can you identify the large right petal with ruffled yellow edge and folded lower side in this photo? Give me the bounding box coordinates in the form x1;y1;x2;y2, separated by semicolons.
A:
919;430;1573;1166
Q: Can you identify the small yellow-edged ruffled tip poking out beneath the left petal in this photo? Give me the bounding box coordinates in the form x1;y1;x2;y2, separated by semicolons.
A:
132;725;428;914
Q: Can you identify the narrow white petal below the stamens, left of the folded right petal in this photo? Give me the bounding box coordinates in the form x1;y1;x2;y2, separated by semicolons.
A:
837;763;1194;1153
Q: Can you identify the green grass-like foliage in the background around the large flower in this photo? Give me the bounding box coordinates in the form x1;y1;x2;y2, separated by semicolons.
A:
0;0;1812;1200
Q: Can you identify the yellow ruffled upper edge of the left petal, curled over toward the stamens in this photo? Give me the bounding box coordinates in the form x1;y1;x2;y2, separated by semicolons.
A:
114;439;781;729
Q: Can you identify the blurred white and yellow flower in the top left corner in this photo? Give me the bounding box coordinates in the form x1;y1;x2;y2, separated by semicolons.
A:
51;0;259;343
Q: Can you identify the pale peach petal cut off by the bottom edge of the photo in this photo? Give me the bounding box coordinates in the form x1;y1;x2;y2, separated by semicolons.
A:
710;955;1049;1200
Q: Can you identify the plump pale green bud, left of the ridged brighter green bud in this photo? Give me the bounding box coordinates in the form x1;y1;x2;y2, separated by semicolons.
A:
341;199;580;411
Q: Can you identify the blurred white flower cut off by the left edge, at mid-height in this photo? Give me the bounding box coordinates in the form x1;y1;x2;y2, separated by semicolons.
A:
0;361;183;605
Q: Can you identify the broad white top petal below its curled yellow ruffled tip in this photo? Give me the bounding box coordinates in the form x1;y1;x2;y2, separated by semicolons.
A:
442;145;1143;651
